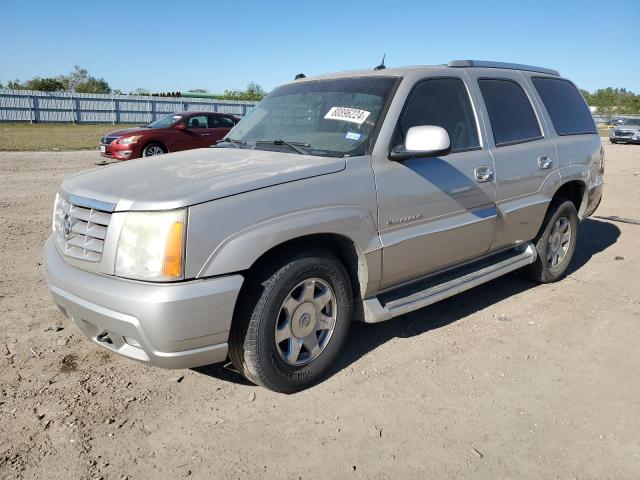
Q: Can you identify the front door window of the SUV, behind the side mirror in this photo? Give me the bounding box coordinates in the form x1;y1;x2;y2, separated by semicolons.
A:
394;78;480;151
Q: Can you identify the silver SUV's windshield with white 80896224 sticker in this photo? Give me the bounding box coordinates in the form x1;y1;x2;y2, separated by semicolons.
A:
226;76;396;156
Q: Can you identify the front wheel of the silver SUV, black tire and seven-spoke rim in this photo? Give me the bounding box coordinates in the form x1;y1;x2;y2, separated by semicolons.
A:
229;250;353;393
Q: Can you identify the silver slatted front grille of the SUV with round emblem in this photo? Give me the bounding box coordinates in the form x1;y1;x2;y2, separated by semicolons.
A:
53;195;111;262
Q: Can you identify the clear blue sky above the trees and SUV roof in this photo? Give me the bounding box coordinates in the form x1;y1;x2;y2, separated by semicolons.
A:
0;0;640;93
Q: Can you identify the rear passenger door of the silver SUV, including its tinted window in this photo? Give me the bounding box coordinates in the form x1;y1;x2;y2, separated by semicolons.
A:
467;72;558;250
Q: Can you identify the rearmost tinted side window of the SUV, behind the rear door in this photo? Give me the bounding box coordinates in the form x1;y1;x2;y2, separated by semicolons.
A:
531;77;597;135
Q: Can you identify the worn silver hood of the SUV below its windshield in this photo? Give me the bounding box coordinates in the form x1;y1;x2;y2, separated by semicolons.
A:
62;148;346;211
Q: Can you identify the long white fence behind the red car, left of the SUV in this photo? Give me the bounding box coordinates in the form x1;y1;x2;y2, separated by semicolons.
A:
0;88;255;124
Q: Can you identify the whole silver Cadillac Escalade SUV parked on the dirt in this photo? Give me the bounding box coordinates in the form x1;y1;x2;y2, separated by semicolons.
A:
45;60;604;392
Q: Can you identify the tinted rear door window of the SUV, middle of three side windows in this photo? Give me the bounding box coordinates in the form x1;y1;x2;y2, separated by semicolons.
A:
478;78;542;147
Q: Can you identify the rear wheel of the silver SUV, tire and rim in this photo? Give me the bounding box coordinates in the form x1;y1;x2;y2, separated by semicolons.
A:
523;199;579;283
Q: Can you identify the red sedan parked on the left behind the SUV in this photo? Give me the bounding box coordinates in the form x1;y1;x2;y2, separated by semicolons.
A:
100;112;240;160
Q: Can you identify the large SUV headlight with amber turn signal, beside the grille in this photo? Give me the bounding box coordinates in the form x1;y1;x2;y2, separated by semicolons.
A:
115;209;187;282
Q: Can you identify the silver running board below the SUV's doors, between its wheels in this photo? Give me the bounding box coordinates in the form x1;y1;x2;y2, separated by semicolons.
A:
364;242;537;323
